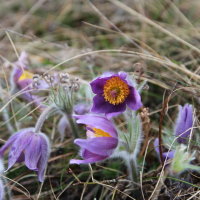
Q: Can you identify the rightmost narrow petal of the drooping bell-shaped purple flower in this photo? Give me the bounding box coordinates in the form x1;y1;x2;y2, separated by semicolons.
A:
38;133;50;182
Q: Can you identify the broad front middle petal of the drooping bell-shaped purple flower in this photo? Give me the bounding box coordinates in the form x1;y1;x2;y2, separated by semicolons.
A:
24;133;41;170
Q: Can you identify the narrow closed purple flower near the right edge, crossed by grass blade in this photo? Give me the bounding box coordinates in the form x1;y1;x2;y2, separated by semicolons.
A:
175;104;194;143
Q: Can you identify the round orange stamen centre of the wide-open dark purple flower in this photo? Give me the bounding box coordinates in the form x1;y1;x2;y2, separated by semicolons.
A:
103;77;130;105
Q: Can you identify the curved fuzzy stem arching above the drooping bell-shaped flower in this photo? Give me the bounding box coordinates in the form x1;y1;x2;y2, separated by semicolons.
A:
35;105;55;133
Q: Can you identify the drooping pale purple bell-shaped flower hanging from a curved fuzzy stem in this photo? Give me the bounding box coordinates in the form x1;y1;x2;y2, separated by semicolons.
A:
0;128;50;182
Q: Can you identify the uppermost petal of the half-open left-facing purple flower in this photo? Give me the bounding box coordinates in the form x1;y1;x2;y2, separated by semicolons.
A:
75;114;117;138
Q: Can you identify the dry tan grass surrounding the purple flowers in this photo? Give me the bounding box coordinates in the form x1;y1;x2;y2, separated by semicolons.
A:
0;0;200;200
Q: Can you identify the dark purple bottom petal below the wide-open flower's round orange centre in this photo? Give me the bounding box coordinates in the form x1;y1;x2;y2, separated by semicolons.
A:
91;95;126;115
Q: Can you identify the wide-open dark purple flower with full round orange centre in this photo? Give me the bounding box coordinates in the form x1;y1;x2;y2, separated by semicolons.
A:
90;72;142;117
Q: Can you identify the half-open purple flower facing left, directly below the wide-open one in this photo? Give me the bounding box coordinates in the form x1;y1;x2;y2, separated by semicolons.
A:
70;114;118;164
